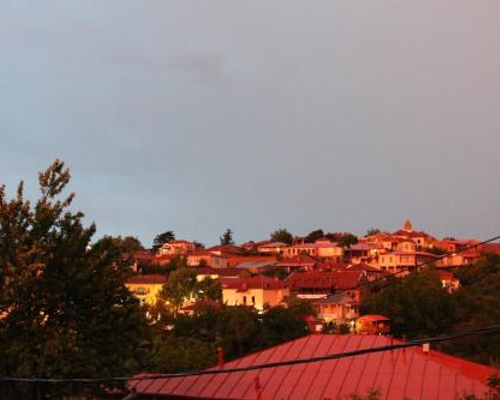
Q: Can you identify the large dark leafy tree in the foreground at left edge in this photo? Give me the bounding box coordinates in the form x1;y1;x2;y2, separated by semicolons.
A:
0;160;149;398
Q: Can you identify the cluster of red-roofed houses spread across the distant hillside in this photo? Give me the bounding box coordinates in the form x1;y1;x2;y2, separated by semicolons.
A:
127;220;492;326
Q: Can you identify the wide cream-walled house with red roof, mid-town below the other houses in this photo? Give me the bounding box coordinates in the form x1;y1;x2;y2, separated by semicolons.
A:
220;275;290;311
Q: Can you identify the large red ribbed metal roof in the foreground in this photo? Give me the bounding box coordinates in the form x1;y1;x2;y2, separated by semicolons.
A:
131;334;496;400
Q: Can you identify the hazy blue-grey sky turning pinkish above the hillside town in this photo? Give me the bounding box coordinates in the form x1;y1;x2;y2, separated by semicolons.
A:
0;0;500;245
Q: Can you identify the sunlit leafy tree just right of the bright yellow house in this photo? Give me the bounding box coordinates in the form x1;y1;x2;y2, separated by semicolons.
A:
160;268;196;314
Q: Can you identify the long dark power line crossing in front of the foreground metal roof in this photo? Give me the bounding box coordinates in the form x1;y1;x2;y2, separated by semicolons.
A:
0;324;500;384
